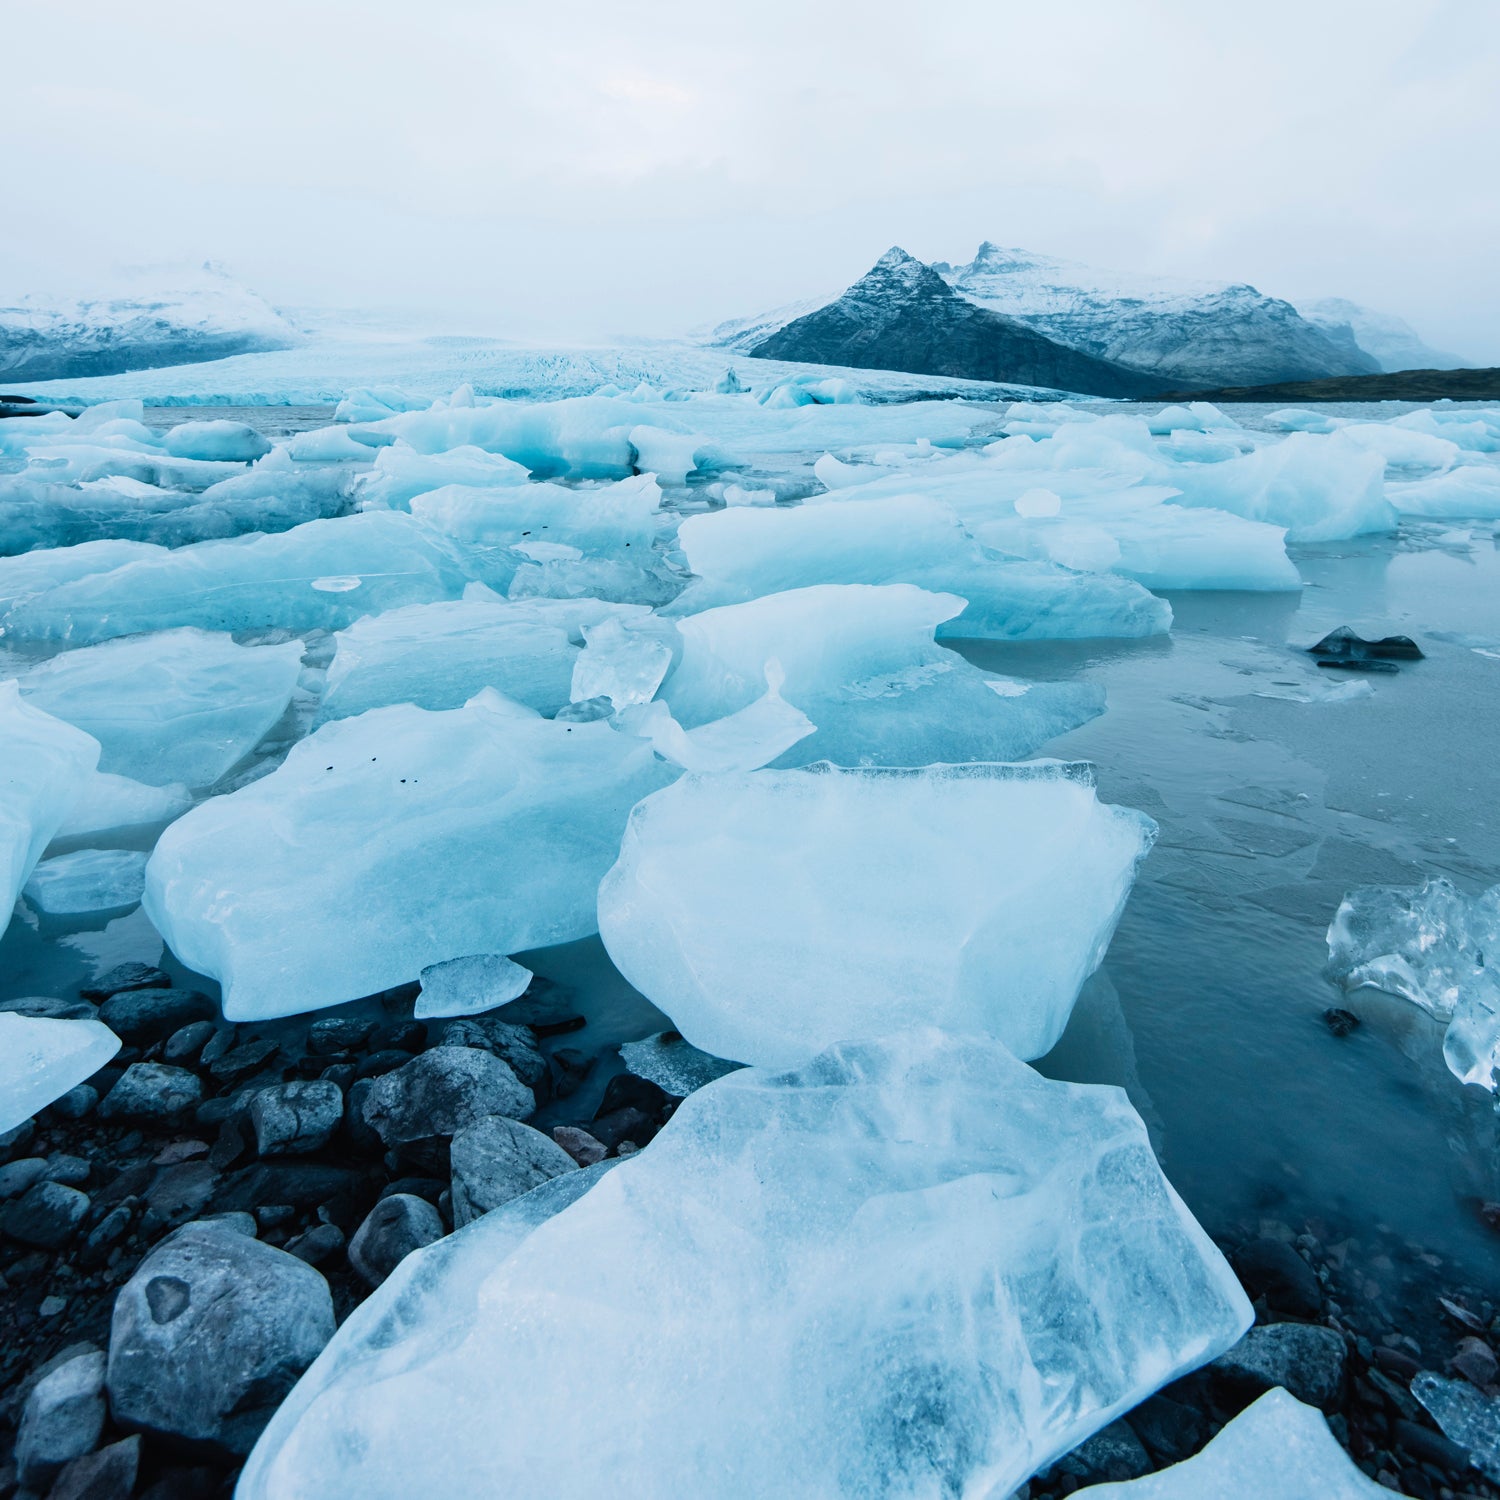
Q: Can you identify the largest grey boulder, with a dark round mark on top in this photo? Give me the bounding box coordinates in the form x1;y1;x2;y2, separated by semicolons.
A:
108;1224;333;1457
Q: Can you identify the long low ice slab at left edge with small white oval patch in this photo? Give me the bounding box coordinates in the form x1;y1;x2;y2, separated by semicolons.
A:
0;512;498;645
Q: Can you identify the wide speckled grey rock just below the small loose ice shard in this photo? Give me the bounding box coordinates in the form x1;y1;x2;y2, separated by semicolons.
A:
365;1047;536;1148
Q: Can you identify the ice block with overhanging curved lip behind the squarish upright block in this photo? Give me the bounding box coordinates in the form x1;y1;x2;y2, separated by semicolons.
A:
662;584;1104;767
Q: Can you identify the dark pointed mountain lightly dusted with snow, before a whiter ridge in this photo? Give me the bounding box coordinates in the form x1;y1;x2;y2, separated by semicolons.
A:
746;246;1169;398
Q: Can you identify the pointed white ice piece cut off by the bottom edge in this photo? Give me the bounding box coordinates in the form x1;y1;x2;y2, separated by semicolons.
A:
1074;1376;1380;1500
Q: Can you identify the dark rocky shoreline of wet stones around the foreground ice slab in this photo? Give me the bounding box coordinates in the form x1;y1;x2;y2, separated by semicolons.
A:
0;965;1500;1500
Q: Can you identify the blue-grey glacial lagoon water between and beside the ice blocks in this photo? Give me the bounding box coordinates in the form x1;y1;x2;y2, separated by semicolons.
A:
0;404;1500;1328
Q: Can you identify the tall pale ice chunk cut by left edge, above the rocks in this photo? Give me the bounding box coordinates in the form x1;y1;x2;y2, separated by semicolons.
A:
0;681;99;933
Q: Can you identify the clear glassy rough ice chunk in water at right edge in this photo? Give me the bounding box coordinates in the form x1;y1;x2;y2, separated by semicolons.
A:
1328;879;1500;1091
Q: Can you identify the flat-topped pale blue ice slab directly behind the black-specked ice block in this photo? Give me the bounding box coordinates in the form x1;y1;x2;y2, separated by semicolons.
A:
318;599;647;723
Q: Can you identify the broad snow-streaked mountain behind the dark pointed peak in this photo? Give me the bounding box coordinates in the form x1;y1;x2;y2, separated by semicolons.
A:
935;240;1380;387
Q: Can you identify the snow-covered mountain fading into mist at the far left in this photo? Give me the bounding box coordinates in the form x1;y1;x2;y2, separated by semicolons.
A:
0;266;300;384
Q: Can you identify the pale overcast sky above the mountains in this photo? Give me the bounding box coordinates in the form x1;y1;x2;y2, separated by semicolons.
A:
11;0;1500;363
